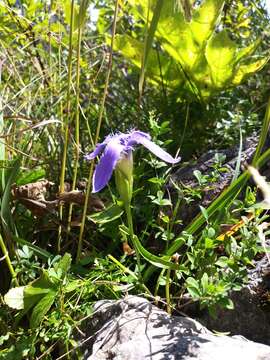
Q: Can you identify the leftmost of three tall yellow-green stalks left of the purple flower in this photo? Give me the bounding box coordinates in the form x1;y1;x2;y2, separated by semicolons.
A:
57;0;75;252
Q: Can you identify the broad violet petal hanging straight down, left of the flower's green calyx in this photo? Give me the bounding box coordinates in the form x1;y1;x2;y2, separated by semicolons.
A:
93;138;124;193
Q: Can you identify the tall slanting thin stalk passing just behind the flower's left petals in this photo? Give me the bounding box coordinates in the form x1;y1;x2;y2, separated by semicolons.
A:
76;0;118;263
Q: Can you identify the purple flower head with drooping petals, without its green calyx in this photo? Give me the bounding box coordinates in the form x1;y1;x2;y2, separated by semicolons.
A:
85;130;180;193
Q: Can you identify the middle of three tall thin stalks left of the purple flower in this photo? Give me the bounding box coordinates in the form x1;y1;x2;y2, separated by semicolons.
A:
67;26;82;236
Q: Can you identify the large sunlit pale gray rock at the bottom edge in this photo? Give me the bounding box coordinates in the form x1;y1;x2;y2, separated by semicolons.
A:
82;296;270;360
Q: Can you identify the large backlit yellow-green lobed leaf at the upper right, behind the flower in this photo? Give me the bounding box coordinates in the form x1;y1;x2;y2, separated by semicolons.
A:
113;0;268;100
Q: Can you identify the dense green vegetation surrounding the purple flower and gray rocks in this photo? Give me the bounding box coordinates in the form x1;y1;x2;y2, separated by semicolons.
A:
0;0;270;359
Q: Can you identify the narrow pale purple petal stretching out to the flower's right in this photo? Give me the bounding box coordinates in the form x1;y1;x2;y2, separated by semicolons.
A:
129;131;181;164
